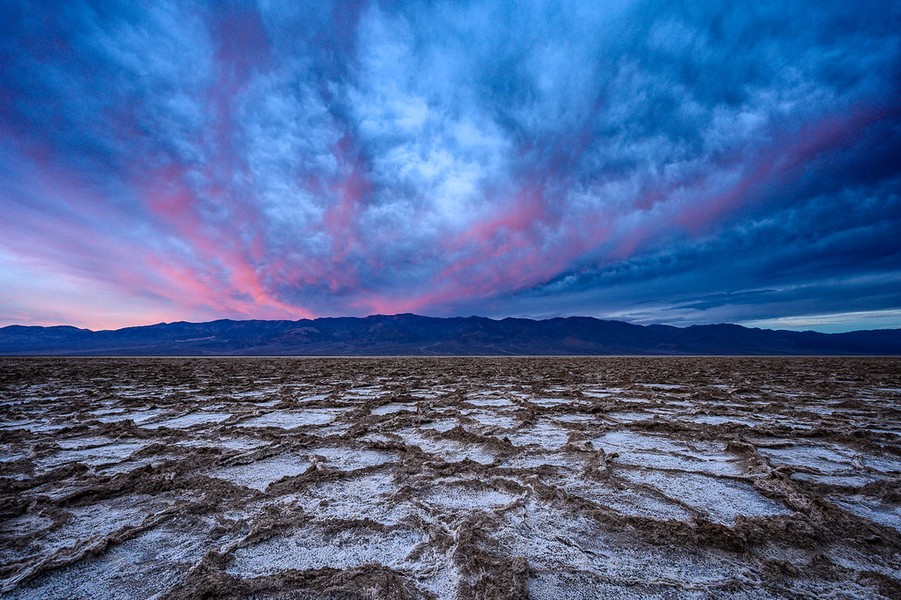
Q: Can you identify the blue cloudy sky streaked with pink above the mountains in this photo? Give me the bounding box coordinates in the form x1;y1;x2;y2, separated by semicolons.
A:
0;0;901;331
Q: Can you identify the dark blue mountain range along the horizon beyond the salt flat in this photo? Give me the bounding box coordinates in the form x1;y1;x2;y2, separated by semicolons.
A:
0;314;901;356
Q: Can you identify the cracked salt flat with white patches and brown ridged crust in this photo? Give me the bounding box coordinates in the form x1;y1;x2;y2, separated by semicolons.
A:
0;358;901;598
